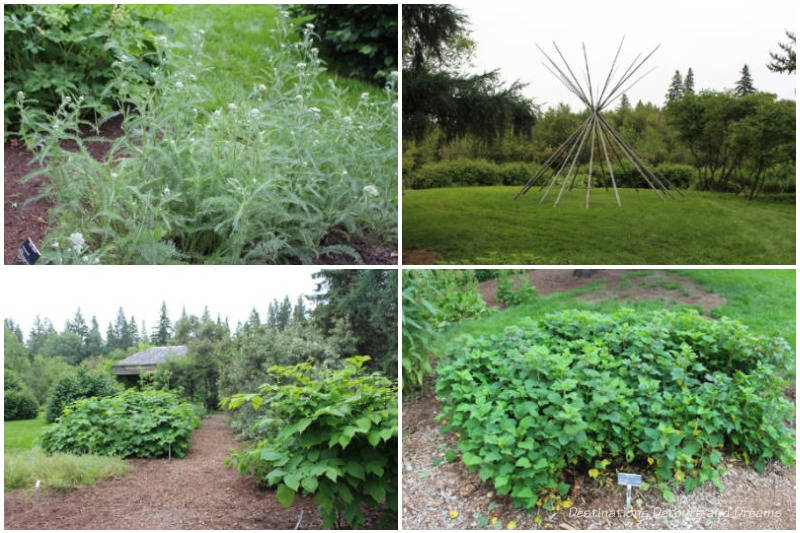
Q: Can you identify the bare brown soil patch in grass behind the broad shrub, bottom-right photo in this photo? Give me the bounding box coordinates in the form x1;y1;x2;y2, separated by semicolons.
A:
478;269;725;313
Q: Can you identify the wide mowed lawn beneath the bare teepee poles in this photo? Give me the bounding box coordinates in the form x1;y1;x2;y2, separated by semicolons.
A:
403;186;795;265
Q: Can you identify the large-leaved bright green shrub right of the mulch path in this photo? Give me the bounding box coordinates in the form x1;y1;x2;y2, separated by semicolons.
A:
224;356;397;528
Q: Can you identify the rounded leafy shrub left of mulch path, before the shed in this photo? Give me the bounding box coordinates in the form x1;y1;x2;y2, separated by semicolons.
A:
39;389;199;458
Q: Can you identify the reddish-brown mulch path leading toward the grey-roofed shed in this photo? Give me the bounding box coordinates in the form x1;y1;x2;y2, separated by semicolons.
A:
5;414;390;530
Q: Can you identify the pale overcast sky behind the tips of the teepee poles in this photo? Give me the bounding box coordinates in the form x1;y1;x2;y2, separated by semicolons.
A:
455;0;797;109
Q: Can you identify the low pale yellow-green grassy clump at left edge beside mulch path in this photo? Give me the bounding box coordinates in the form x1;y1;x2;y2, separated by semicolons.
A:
3;448;131;490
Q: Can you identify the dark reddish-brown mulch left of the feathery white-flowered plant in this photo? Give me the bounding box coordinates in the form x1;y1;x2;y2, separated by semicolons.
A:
3;117;123;265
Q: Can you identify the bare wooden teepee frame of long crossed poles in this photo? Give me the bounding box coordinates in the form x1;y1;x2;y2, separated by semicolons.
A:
514;37;683;208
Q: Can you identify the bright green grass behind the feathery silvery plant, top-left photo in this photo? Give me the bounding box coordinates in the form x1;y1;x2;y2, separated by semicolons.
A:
159;4;382;111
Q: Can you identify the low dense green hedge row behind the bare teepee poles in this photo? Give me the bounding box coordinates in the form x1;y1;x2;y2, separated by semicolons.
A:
403;159;695;189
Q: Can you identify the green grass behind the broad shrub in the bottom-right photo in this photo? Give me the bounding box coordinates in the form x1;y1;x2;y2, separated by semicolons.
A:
434;270;796;354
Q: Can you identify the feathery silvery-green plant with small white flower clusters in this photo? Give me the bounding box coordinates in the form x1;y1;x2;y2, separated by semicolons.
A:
17;17;397;264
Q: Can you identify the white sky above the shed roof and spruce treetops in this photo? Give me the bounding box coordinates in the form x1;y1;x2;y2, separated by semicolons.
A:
2;266;328;338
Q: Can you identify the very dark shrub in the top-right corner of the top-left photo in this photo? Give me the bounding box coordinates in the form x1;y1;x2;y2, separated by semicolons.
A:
289;4;397;80
